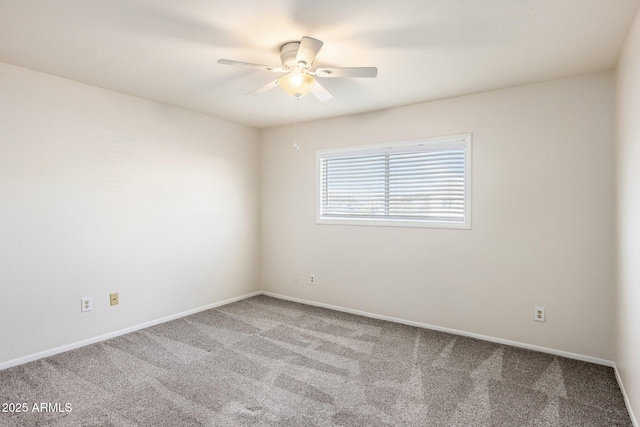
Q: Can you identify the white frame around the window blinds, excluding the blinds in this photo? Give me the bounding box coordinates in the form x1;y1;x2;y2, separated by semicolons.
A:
316;133;473;230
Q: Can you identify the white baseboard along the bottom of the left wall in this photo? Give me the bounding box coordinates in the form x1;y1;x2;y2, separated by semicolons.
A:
0;291;262;371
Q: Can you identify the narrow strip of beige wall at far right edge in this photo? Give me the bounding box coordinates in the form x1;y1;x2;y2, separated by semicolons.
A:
616;5;640;422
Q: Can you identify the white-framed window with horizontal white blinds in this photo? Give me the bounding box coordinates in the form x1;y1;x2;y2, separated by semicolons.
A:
316;134;471;228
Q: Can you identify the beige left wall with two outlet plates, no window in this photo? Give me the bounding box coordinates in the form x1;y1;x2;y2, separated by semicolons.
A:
0;64;258;365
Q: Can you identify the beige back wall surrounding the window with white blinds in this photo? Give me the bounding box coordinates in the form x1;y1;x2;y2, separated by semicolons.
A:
260;73;615;361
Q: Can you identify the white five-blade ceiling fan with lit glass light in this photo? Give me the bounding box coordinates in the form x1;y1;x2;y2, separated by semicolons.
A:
218;37;378;101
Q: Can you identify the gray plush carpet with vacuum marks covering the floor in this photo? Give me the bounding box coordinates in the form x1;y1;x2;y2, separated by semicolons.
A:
0;296;631;427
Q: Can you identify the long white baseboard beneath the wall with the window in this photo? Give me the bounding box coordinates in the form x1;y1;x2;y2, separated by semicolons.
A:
261;291;615;368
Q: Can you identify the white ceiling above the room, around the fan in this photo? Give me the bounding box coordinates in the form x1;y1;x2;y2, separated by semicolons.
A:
0;0;640;127
